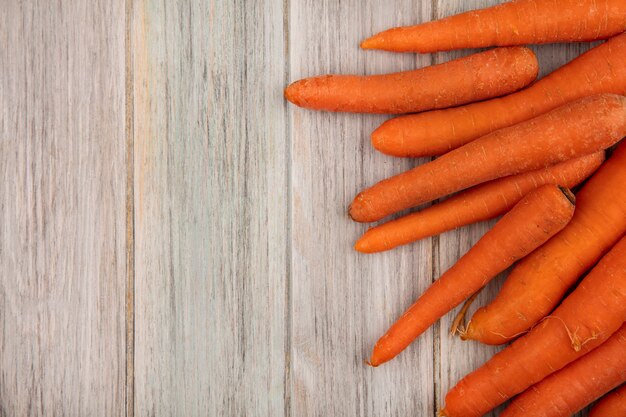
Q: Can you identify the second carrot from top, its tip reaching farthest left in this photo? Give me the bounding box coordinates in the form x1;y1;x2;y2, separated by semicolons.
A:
285;47;539;114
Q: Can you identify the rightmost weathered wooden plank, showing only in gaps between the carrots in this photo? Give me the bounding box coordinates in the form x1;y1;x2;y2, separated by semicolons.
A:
435;0;590;416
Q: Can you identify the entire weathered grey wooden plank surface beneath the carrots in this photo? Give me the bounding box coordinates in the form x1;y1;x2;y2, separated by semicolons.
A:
0;0;588;417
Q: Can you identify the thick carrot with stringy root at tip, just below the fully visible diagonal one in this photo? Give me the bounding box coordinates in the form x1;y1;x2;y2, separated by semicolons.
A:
463;143;626;345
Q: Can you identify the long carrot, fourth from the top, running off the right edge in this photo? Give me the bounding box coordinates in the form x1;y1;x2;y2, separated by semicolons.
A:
350;94;626;222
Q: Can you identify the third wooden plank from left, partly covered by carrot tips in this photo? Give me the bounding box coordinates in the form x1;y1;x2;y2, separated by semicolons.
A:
289;0;434;416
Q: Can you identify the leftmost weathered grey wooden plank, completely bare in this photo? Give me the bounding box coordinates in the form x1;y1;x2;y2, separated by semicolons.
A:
0;0;126;416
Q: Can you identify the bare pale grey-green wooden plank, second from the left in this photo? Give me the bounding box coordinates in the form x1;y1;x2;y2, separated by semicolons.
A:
132;0;289;416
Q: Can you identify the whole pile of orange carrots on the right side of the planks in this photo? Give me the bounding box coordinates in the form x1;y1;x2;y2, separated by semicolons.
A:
285;0;626;417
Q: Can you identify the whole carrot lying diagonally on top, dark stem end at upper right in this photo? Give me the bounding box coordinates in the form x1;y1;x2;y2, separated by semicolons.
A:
369;185;574;366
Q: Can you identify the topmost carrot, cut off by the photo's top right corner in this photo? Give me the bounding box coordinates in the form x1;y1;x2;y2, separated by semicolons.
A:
361;0;626;53
